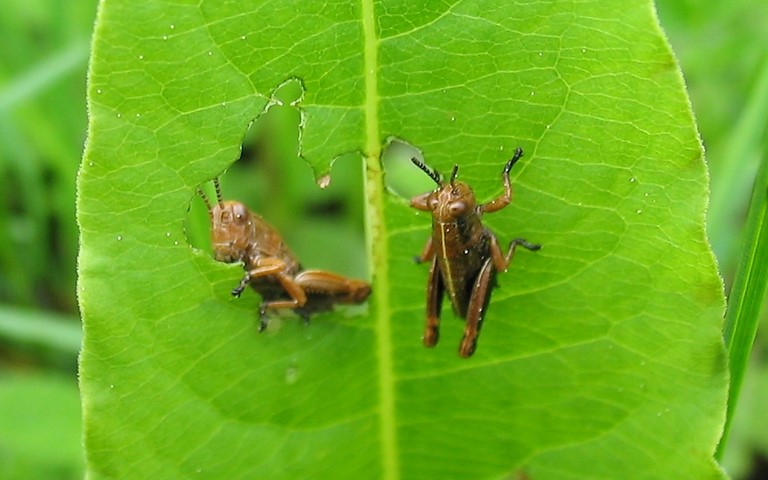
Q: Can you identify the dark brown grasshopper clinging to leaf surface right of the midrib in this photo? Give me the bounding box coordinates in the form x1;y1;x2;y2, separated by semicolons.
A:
411;148;541;358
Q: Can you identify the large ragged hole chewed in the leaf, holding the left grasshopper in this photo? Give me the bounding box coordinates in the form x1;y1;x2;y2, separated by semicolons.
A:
185;78;370;316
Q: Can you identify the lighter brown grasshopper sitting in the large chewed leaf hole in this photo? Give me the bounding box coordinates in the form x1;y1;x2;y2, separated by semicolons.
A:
198;178;371;332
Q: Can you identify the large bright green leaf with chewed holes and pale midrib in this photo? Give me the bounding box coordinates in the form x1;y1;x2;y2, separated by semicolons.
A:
78;0;727;479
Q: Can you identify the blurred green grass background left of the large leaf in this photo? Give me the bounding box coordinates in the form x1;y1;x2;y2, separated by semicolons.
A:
0;0;96;479
